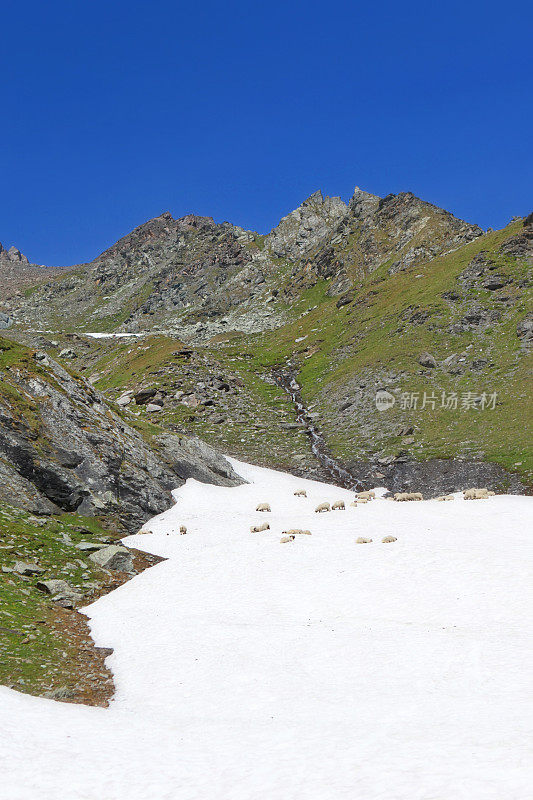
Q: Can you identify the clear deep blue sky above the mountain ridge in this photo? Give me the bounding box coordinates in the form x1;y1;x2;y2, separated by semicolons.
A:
0;0;533;264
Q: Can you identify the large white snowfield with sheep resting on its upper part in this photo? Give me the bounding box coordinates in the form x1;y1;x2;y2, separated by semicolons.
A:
0;462;533;800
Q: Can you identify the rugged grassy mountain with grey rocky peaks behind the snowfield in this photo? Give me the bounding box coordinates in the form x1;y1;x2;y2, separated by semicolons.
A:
2;188;533;494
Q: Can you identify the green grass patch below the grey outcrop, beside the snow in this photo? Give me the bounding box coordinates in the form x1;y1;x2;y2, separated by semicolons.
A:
0;505;120;694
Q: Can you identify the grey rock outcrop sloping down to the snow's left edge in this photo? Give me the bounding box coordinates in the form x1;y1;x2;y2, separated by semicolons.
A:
0;339;242;528
